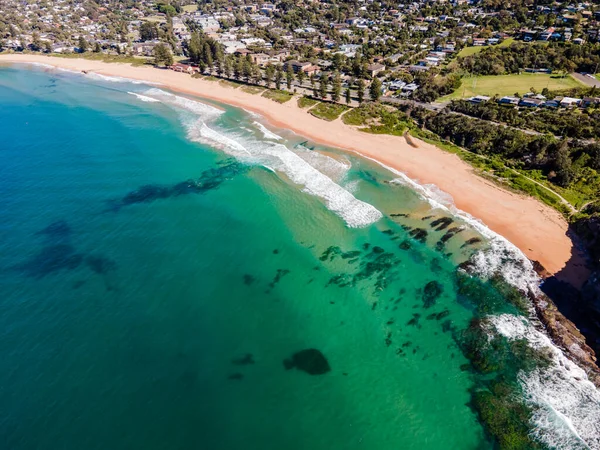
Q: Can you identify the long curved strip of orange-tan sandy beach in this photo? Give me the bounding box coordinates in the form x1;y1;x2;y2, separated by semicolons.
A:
0;54;586;285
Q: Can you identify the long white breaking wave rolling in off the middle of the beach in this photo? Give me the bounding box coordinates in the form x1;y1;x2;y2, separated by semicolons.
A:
139;88;383;228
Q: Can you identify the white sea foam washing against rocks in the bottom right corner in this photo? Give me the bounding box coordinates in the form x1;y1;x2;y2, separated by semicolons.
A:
489;314;600;450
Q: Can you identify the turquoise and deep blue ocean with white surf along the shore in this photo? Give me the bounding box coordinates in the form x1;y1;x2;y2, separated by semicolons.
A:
0;65;600;450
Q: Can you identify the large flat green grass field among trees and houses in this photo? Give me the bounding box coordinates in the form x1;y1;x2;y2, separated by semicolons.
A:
439;73;583;102
